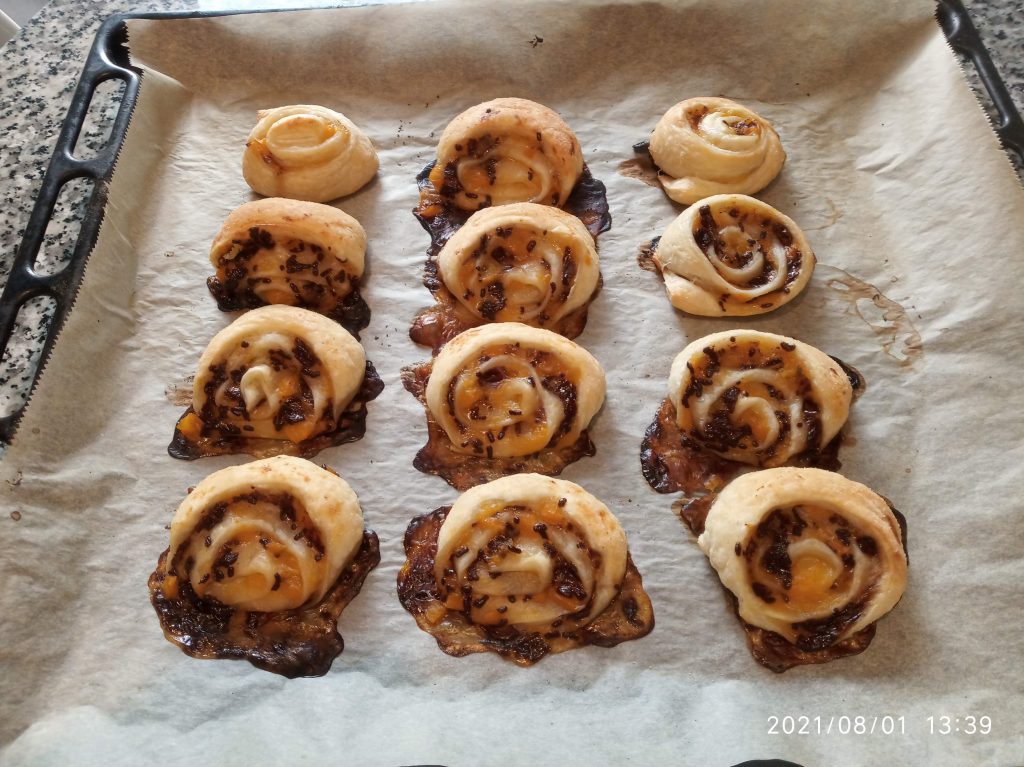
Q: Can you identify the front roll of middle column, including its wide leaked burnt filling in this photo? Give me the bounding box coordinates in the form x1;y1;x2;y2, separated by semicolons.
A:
398;474;654;666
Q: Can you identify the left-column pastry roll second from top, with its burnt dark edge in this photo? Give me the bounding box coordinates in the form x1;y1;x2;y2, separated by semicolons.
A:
207;198;370;332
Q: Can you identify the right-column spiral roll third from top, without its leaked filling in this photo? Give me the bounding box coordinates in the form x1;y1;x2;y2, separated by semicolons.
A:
669;330;853;467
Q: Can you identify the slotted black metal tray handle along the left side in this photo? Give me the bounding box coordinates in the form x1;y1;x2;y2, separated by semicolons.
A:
0;15;140;443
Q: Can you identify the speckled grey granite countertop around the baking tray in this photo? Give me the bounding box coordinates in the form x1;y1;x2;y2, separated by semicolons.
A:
0;0;1024;430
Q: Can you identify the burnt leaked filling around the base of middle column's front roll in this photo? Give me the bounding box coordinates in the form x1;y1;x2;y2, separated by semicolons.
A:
397;506;654;667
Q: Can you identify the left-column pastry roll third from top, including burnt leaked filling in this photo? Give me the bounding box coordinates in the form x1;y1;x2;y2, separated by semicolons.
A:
169;306;383;459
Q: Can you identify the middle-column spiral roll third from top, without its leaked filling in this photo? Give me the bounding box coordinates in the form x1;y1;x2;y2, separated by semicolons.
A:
426;323;604;458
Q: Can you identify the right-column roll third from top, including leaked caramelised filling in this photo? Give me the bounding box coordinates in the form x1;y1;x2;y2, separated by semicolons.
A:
640;330;864;494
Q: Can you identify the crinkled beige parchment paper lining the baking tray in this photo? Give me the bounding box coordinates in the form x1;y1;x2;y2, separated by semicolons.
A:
0;0;1024;765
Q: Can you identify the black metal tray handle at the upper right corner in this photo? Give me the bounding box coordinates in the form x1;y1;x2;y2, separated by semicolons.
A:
936;0;1024;160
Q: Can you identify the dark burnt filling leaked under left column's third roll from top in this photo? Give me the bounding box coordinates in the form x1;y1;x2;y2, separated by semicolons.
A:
167;359;384;461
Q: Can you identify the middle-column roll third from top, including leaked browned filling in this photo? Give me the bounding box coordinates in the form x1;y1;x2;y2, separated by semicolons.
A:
403;323;605;489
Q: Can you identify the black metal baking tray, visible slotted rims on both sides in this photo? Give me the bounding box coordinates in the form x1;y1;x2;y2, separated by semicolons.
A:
0;0;1024;443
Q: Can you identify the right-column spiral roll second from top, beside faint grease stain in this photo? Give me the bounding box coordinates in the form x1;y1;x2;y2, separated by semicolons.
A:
654;195;815;316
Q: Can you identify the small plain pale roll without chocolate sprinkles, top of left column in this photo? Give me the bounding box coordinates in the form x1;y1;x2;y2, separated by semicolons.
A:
242;104;379;203
